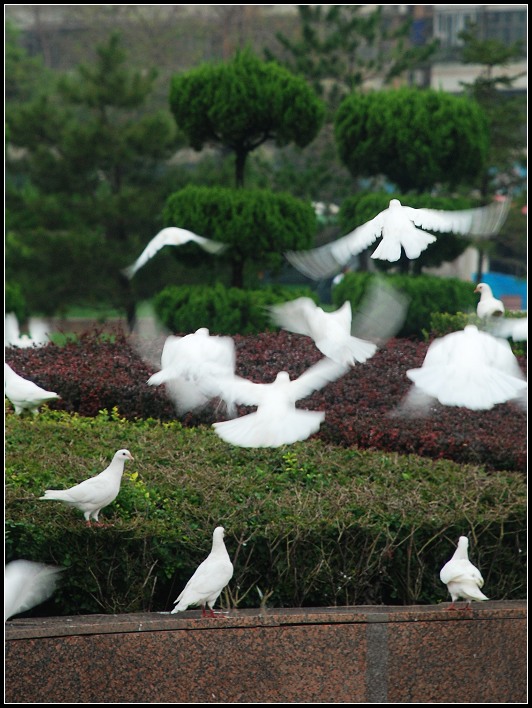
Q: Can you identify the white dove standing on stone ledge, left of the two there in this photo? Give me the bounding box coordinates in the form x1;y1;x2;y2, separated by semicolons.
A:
171;526;233;617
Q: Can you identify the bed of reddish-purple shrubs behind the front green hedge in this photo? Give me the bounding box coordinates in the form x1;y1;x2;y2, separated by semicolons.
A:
6;331;527;472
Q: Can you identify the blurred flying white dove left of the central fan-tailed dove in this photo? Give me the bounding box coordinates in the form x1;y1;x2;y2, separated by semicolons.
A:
148;327;236;416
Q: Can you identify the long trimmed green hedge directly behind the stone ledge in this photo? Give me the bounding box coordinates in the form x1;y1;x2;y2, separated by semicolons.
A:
5;408;527;615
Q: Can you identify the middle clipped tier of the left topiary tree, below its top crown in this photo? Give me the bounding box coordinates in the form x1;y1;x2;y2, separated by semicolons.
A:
164;185;317;288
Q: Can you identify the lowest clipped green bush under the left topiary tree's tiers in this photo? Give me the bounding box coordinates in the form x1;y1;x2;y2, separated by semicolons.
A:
153;283;317;335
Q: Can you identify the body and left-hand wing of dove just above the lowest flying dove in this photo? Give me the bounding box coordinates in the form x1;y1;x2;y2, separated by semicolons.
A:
270;297;377;366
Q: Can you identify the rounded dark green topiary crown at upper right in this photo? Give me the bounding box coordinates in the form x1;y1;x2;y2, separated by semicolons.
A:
335;87;489;192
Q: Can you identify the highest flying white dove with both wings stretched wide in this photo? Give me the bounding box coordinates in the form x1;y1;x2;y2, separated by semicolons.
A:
285;199;510;280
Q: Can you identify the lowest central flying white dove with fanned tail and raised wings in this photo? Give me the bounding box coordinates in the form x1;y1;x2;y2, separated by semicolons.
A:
208;358;349;447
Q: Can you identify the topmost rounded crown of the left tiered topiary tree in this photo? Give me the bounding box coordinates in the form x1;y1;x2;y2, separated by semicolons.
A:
170;49;325;187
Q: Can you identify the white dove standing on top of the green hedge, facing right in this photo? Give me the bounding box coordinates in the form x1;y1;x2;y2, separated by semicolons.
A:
39;450;134;526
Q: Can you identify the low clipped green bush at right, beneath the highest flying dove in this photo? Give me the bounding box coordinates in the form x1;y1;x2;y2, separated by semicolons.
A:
332;273;478;338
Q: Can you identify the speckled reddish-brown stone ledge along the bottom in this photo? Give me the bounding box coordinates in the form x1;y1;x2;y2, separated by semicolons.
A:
5;601;527;703
